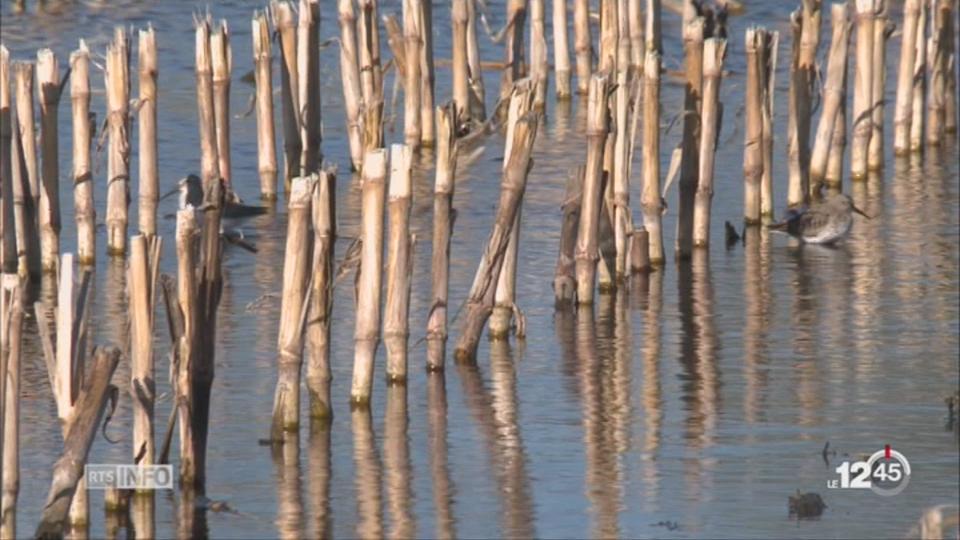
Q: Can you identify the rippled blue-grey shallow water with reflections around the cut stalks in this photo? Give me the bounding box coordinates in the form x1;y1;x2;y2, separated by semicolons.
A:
2;0;960;538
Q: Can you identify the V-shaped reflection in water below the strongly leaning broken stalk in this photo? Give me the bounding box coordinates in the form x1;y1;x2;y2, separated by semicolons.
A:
457;340;536;538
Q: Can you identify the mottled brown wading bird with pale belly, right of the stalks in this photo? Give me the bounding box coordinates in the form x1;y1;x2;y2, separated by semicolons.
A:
770;193;872;244
